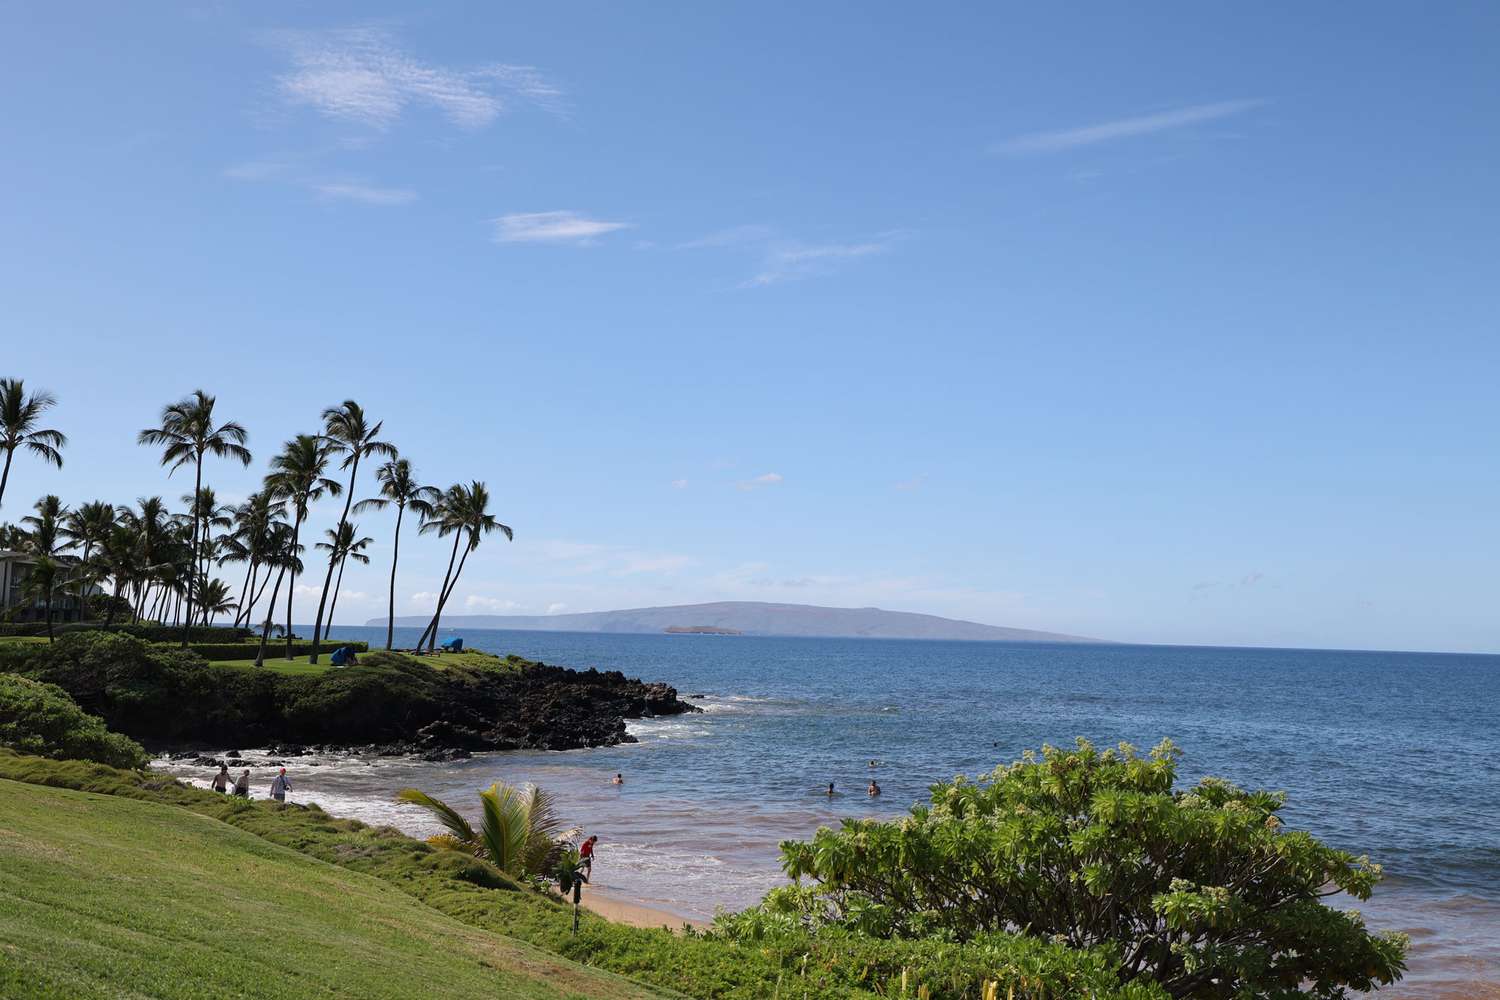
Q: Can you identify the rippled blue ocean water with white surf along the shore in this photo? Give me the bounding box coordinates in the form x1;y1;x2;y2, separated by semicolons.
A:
155;628;1500;997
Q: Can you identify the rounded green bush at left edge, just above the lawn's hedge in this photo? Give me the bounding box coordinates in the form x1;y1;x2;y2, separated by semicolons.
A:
0;673;150;768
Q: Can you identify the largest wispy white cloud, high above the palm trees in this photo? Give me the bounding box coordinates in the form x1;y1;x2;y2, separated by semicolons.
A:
266;27;563;129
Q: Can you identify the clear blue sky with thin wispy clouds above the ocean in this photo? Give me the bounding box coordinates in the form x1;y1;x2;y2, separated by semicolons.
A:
0;3;1500;649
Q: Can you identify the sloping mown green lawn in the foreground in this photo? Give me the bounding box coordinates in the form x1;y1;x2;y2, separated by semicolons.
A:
0;780;662;1000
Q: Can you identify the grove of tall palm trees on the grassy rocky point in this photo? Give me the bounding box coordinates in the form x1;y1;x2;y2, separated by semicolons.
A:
0;378;513;663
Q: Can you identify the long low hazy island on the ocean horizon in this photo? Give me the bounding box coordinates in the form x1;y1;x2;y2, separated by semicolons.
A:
375;601;1101;642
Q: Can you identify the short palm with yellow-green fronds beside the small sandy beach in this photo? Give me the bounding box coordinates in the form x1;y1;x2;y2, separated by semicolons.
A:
396;781;578;879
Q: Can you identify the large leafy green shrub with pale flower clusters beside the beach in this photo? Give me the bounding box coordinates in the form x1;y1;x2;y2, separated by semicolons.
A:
723;741;1406;997
